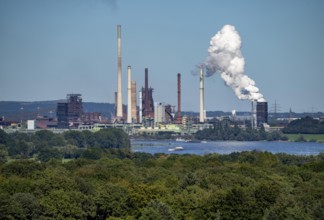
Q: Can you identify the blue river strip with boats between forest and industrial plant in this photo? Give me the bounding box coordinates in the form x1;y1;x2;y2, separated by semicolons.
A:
131;140;324;155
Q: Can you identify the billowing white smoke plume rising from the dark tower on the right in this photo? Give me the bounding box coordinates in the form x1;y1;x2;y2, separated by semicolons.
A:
204;25;265;102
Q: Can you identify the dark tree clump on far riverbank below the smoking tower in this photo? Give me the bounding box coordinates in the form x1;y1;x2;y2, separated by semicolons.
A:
195;121;288;141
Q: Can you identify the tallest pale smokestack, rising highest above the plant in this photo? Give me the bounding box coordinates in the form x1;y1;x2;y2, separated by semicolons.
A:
116;25;123;118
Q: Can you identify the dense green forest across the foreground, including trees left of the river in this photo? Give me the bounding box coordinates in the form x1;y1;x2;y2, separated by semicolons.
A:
0;129;324;220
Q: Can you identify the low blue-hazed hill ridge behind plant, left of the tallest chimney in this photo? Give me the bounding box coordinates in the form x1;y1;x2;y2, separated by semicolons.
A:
0;100;114;121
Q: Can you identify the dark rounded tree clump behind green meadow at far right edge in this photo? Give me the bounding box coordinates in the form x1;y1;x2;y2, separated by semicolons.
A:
282;116;324;134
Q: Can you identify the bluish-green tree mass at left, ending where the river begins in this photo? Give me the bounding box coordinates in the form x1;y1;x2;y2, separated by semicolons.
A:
0;128;130;162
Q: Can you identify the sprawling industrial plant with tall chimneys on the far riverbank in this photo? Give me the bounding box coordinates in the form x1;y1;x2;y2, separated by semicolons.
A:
0;25;268;135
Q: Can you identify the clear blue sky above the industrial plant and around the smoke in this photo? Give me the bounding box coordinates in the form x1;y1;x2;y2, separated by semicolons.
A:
0;0;324;112
